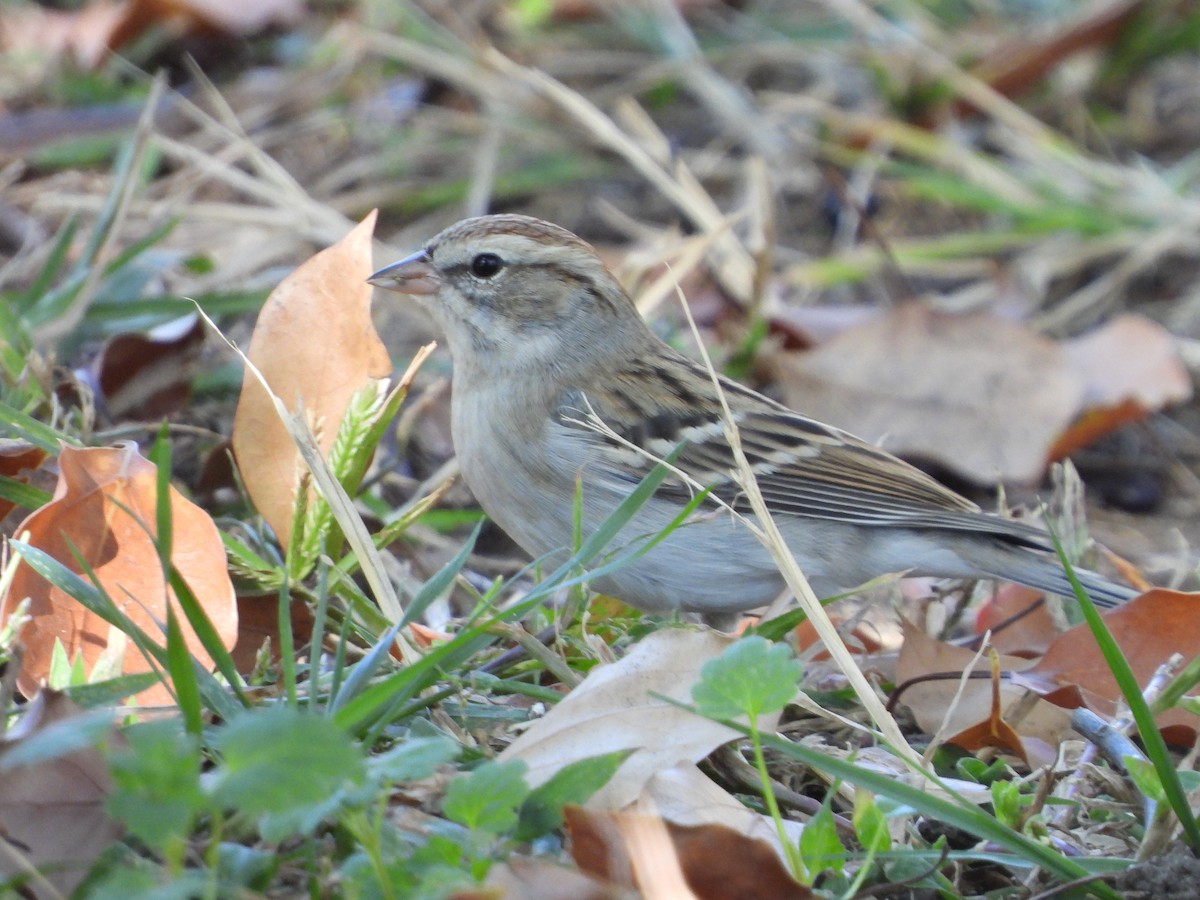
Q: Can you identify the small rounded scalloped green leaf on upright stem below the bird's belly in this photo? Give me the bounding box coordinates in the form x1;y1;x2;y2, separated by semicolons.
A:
691;636;804;719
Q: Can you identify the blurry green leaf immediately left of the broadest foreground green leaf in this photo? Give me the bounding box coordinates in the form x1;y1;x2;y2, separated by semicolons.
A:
108;720;208;852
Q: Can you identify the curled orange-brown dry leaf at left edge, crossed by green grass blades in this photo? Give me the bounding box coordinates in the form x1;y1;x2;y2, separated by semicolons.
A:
0;442;238;703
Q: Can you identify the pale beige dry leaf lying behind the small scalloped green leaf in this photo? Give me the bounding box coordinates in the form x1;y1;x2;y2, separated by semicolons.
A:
499;629;773;809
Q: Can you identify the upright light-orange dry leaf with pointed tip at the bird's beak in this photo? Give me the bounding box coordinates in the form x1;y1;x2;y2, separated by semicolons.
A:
233;211;391;547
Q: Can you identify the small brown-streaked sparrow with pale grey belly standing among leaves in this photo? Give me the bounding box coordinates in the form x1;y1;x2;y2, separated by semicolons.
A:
368;215;1136;616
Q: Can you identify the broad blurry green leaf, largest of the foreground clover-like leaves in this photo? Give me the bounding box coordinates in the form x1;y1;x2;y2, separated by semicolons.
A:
206;707;366;816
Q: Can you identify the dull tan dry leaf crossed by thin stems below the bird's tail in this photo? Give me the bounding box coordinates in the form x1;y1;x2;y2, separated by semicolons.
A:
896;619;1072;766
